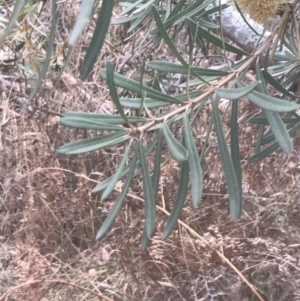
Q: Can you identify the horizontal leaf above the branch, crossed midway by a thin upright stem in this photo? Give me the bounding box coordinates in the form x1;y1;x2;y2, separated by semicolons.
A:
147;61;229;76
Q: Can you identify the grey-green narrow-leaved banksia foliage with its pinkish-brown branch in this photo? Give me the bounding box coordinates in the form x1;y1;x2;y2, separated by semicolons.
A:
4;0;300;248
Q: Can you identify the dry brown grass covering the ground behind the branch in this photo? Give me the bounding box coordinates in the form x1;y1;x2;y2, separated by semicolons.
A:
0;1;300;301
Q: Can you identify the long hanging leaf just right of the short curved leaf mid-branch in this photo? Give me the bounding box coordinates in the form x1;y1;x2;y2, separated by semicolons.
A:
183;112;203;208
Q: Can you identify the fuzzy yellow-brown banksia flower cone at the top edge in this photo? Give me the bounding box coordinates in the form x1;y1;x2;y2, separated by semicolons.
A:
233;0;289;23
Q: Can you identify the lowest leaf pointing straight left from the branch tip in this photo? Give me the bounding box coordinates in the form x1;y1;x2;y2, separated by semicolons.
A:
57;132;130;155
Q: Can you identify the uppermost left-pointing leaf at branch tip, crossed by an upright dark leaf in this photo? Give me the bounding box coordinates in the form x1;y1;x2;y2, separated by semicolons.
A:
62;111;148;124
